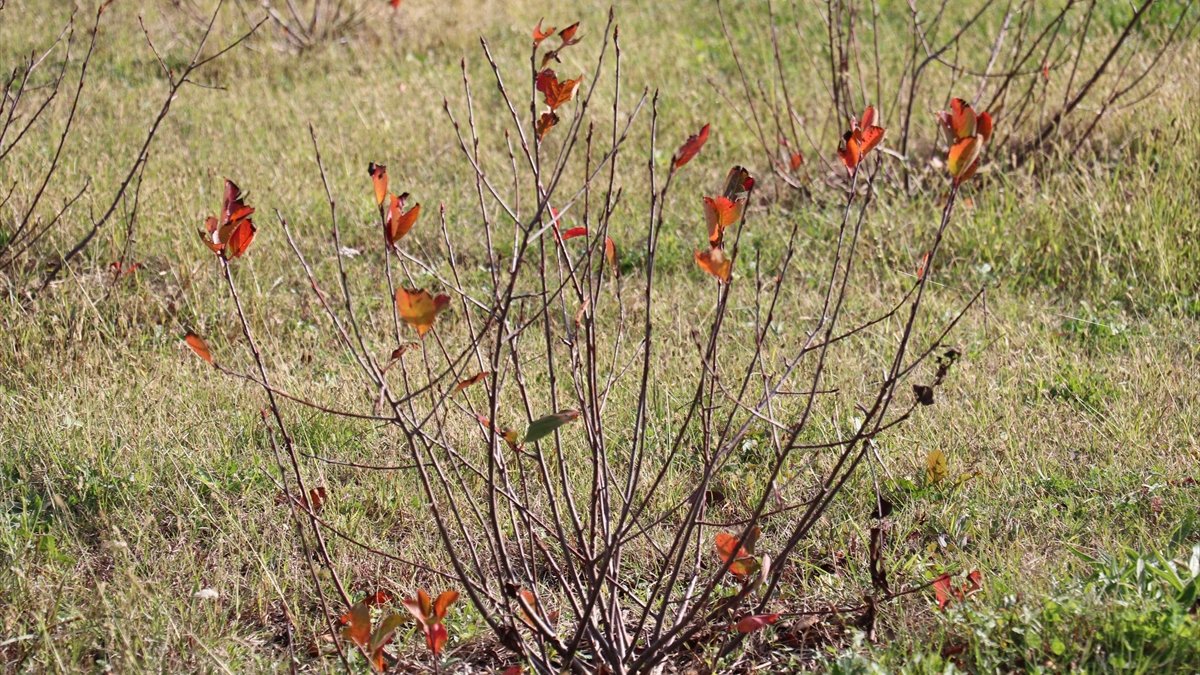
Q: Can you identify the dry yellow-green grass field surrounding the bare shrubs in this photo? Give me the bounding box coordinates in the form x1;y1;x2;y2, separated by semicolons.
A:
0;0;1200;673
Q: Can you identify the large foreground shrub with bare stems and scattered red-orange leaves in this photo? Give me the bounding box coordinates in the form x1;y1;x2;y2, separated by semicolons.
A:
188;9;992;673
